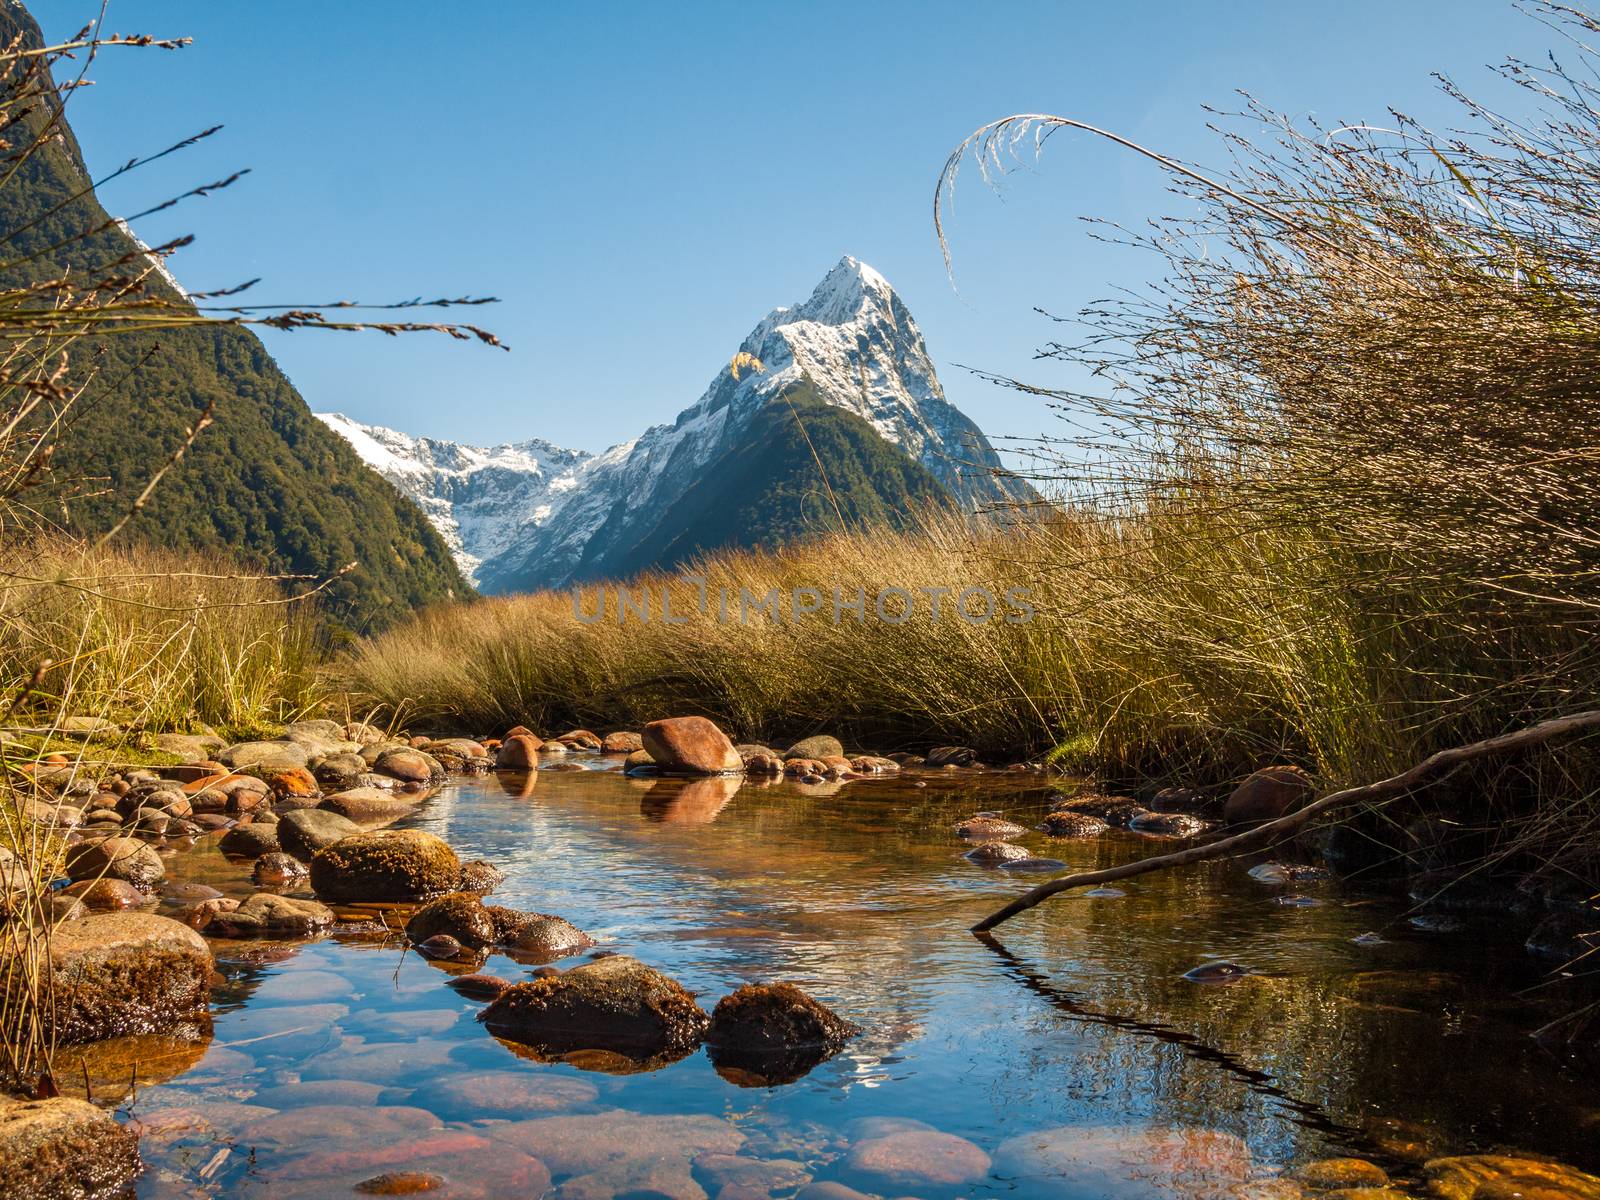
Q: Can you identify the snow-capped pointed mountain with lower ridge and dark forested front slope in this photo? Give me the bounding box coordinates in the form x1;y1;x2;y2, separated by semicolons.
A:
323;256;1038;592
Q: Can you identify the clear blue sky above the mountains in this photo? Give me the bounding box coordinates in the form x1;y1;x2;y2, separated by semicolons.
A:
34;0;1554;450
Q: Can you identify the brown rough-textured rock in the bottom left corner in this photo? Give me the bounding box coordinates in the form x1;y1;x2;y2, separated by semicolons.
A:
0;1096;144;1200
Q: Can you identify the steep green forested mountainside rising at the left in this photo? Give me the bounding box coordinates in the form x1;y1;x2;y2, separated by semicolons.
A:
0;0;470;629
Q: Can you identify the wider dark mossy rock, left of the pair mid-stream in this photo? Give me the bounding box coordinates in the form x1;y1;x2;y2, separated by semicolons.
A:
478;955;710;1059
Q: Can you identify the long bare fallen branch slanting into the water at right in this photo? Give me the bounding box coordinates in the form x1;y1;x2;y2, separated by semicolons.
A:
973;709;1600;933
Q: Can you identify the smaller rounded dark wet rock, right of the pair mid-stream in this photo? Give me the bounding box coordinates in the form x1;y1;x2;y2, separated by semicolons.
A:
706;984;861;1085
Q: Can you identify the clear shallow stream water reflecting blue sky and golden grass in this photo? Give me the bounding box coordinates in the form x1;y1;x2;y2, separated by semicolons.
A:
90;760;1600;1200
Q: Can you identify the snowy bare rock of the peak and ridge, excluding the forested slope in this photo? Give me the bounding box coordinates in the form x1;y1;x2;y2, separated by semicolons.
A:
323;258;1037;592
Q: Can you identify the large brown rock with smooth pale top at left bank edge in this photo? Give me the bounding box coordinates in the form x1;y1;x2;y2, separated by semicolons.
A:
28;912;211;1045
